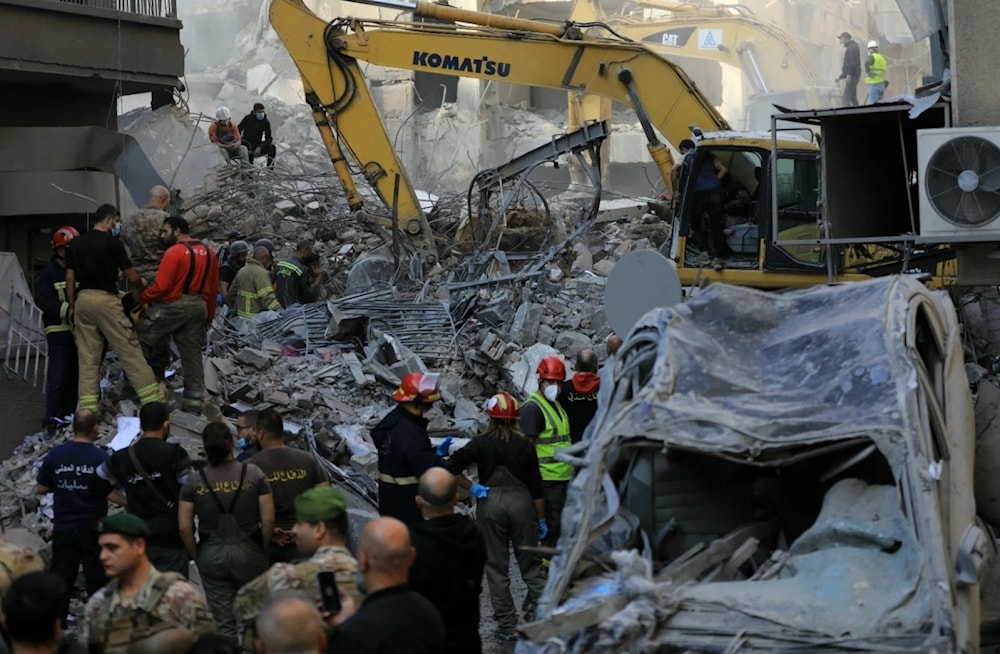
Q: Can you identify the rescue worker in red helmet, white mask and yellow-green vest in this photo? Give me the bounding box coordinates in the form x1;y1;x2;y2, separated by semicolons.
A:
520;354;573;547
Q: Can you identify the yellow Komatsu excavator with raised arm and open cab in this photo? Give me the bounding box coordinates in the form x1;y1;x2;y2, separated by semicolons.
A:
270;0;948;288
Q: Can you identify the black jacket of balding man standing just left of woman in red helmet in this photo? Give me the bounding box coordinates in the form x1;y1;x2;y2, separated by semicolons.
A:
410;514;486;654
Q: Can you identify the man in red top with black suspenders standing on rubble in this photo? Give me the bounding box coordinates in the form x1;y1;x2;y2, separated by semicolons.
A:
136;216;219;415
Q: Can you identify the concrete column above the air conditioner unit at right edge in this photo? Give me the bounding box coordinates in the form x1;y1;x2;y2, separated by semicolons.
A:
948;0;1000;127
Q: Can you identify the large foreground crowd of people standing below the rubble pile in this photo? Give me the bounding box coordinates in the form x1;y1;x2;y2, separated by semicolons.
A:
15;337;620;654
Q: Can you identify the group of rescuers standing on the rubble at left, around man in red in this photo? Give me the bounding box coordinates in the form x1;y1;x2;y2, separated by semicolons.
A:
35;179;326;435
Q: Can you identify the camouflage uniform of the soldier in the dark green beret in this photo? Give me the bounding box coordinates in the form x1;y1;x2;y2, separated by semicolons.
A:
80;568;215;654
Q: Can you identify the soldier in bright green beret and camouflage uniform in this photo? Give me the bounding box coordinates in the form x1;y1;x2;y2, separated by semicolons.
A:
233;486;364;647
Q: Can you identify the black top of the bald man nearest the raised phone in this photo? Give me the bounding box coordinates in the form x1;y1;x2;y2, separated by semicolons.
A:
326;586;446;654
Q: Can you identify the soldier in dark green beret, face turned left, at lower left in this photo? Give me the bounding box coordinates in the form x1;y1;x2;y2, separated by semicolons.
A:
80;513;215;654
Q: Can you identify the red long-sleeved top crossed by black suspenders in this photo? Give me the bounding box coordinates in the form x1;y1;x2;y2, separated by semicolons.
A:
139;239;219;320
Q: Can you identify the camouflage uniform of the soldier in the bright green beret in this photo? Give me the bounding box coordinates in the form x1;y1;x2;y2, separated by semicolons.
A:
233;545;364;651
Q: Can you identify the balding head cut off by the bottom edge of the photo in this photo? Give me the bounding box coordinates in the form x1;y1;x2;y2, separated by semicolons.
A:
254;590;326;654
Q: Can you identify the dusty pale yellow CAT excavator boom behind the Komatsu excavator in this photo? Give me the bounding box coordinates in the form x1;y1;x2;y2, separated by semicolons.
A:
569;0;840;130
